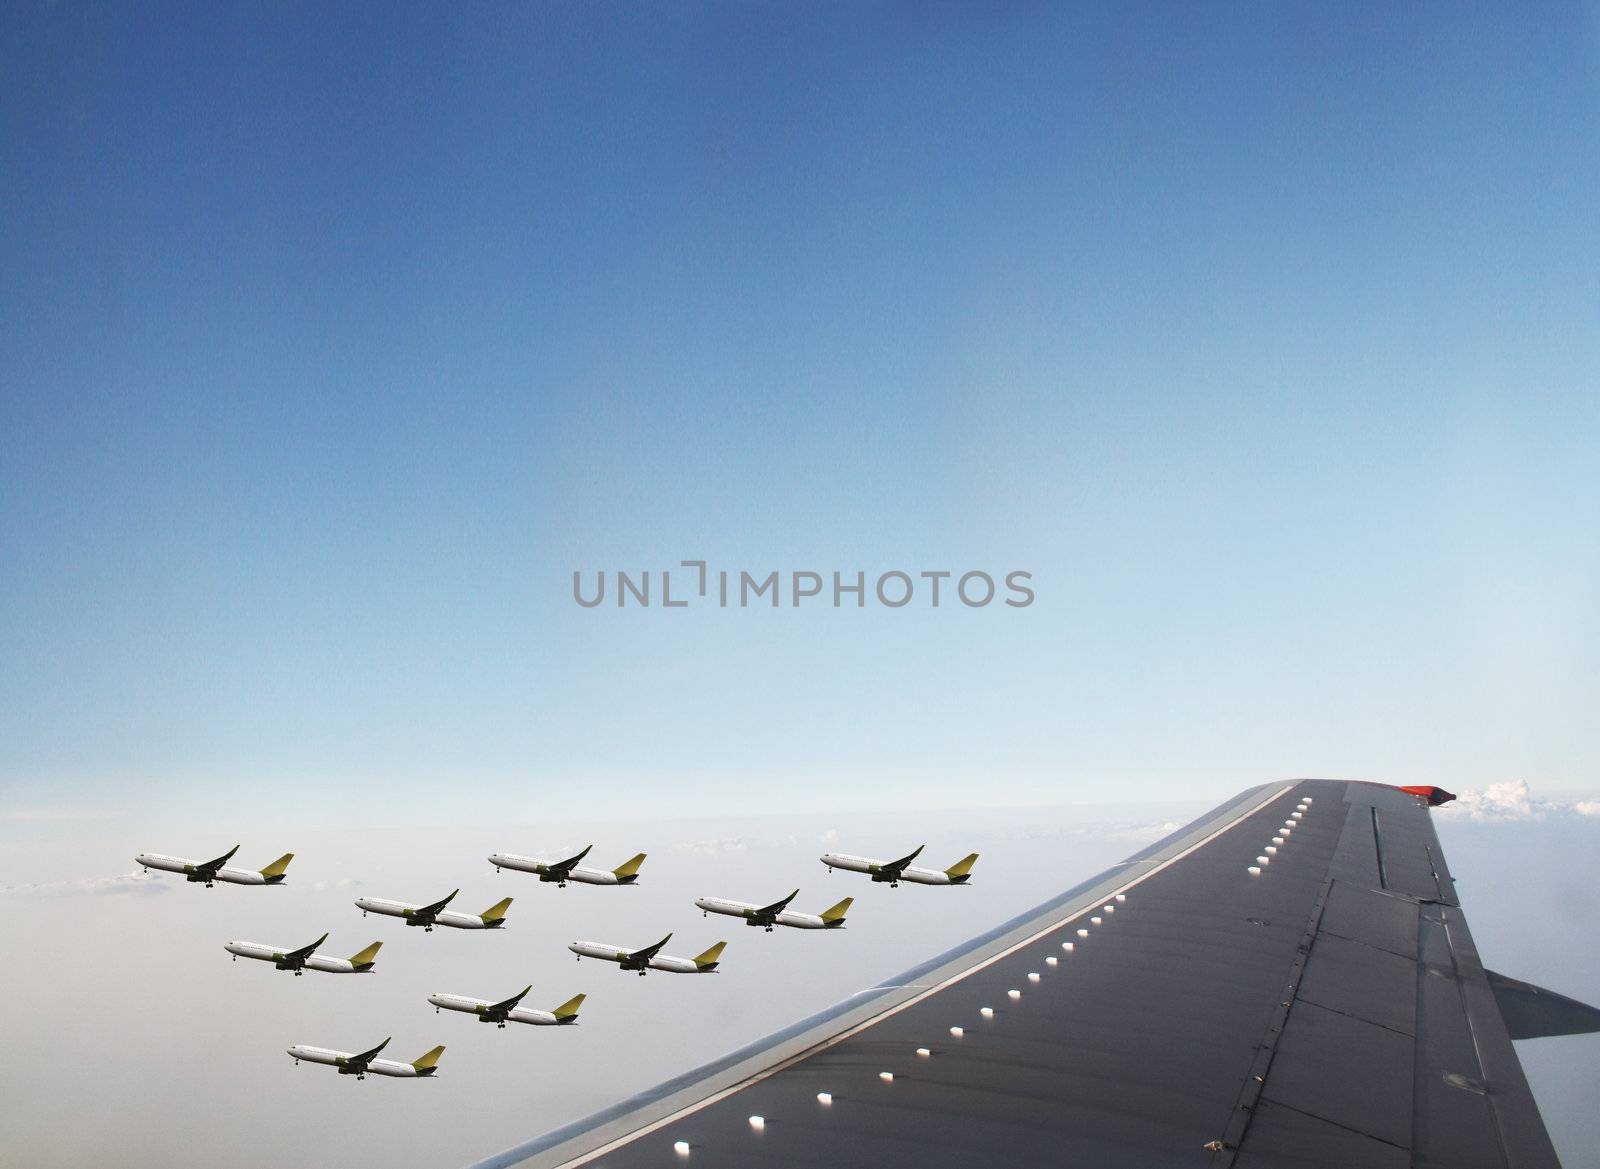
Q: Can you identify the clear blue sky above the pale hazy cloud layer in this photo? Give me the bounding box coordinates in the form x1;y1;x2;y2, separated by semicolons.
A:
0;5;1600;825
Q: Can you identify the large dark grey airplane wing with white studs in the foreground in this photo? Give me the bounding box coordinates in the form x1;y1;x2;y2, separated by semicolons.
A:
478;780;1580;1169
